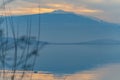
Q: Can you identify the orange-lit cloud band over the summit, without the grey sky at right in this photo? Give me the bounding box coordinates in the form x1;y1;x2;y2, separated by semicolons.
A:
1;0;100;15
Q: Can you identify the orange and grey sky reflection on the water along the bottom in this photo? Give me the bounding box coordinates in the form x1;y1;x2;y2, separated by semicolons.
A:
7;64;120;80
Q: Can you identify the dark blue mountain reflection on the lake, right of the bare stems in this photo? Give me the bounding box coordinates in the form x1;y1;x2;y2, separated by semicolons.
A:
36;45;120;74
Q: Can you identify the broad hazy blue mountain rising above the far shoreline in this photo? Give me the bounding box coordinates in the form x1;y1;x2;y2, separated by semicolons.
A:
1;10;120;42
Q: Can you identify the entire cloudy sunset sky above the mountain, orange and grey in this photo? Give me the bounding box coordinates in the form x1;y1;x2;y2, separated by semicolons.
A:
0;0;120;23
